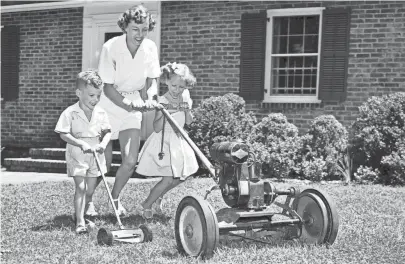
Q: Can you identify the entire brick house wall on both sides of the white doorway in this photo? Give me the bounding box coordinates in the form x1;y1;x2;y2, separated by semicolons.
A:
1;1;405;147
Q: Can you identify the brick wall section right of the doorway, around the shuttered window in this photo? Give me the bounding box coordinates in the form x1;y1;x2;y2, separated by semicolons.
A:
161;1;405;130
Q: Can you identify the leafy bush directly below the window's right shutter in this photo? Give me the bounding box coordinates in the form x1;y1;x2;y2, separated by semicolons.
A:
300;115;348;180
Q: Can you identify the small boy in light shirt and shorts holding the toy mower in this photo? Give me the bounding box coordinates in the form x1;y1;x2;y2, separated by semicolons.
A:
55;70;111;234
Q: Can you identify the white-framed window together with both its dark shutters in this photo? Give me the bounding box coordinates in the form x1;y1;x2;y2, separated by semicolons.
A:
239;8;351;103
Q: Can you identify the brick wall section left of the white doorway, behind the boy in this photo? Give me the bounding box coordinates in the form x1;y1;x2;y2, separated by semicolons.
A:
1;8;83;147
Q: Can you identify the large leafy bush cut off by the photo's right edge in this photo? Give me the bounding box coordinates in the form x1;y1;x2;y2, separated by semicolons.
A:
353;92;405;184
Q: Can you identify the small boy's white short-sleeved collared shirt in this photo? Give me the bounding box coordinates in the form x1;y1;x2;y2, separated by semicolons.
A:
55;102;111;138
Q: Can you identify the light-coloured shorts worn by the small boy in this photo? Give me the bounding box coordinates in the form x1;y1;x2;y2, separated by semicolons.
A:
66;138;107;177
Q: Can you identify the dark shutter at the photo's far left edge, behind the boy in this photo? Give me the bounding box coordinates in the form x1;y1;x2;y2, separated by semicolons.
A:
1;26;20;101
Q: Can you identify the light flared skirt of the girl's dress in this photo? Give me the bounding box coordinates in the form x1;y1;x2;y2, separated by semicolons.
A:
136;109;198;180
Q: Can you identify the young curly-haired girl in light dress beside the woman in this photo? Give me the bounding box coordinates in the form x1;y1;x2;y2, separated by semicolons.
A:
135;63;198;219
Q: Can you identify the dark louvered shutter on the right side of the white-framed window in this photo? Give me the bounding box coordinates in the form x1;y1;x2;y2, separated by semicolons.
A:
319;8;350;101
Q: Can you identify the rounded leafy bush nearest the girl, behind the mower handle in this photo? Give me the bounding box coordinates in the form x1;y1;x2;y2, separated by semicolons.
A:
188;94;256;158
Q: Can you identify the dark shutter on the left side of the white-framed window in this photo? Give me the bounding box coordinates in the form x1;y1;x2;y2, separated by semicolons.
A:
239;12;267;100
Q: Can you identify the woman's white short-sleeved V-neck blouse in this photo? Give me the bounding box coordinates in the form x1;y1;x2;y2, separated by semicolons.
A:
98;34;160;92
